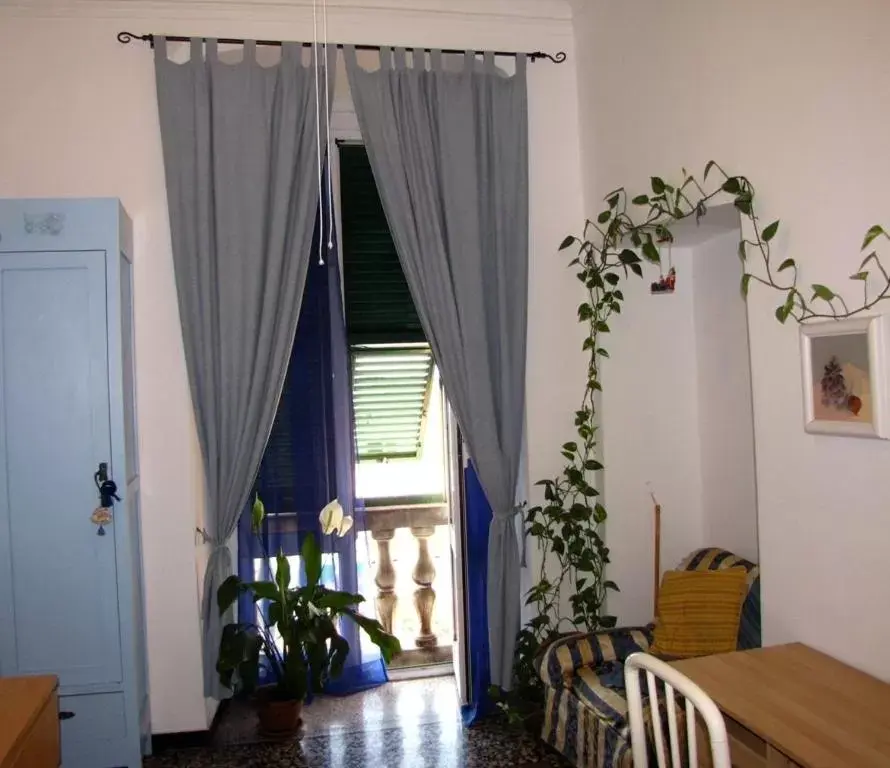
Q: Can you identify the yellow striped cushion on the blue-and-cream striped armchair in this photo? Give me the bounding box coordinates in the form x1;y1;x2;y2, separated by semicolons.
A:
650;568;748;659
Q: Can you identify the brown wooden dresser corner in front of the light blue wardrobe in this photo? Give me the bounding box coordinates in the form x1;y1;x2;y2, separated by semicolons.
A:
0;676;61;768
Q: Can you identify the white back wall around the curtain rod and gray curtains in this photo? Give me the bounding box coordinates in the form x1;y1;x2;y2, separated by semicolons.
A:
0;0;584;732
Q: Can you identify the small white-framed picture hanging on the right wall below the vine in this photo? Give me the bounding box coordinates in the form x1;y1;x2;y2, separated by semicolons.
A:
800;315;890;439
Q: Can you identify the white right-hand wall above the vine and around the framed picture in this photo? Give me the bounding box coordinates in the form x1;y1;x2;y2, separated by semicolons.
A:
575;0;890;679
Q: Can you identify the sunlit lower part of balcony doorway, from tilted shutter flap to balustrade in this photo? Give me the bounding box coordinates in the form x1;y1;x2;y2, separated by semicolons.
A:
353;356;455;674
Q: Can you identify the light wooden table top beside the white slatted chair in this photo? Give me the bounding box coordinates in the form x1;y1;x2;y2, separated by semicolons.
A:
671;643;890;768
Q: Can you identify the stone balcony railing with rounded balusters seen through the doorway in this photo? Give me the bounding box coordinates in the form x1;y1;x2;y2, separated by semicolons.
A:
365;504;454;667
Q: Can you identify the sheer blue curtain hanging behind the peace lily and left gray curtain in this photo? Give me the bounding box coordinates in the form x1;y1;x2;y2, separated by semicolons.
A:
238;192;388;695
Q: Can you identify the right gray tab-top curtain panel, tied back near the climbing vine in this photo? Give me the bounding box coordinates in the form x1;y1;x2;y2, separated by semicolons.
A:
345;47;528;688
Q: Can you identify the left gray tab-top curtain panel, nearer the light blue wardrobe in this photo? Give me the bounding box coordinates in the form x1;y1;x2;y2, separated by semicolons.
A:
155;37;335;698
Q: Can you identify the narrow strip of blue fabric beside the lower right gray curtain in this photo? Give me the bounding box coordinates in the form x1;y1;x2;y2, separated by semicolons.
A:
461;462;495;725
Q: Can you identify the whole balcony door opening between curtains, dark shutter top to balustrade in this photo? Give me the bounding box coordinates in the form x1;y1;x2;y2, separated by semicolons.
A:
337;142;466;688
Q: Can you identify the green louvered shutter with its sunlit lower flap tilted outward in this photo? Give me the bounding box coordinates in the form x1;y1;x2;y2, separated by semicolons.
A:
340;144;433;461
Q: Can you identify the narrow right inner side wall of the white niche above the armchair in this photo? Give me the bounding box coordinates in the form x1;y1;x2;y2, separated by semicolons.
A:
692;231;758;566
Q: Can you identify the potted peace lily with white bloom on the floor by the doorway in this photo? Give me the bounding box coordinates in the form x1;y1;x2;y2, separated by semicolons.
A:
216;496;401;735
